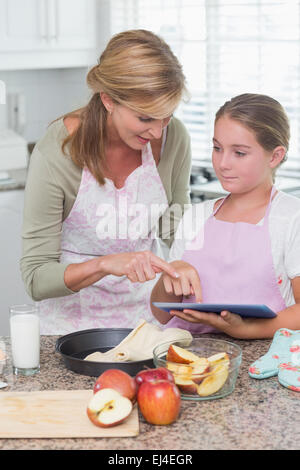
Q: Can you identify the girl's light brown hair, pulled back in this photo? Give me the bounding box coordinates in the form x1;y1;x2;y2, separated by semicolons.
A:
215;93;290;179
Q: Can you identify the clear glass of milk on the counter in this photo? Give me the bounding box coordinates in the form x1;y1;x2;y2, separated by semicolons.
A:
9;304;40;375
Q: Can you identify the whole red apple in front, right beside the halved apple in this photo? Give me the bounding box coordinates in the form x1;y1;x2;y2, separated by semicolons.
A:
137;380;181;425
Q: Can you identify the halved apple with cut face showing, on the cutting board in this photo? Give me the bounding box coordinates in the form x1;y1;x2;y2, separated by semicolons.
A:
87;388;132;428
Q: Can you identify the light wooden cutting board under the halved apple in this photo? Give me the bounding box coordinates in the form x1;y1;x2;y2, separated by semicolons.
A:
0;390;139;438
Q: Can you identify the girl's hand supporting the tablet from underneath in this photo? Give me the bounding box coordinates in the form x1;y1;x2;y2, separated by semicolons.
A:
170;309;252;338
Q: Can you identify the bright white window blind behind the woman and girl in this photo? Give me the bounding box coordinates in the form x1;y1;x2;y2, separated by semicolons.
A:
110;0;300;173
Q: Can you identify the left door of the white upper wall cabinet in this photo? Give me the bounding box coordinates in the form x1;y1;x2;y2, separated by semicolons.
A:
0;0;47;52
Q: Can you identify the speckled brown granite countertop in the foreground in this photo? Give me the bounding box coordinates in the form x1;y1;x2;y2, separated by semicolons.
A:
0;334;300;451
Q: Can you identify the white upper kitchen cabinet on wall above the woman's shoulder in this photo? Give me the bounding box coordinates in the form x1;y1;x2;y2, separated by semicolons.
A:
0;0;96;70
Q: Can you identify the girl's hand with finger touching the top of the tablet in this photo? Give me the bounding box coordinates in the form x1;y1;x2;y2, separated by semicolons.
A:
162;260;202;302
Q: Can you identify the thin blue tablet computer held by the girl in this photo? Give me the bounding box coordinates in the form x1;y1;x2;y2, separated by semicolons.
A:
153;302;277;318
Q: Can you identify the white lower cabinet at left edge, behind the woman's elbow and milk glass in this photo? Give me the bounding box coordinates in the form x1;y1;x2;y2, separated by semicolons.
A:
0;190;34;336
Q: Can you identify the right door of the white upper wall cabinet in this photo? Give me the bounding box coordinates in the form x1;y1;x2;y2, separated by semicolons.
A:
53;0;96;50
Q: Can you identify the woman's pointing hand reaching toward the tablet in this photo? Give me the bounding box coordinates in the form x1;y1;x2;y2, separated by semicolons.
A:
101;251;178;282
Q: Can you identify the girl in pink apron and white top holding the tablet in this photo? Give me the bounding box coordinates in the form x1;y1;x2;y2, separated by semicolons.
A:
151;94;300;338
